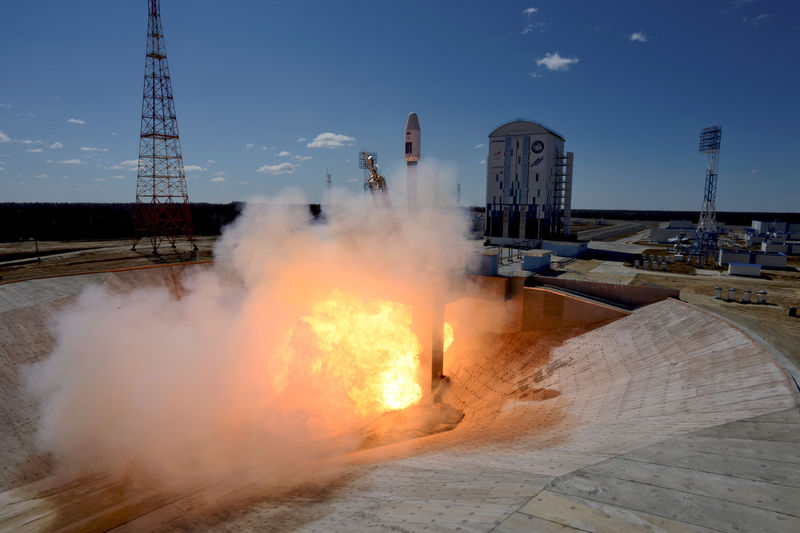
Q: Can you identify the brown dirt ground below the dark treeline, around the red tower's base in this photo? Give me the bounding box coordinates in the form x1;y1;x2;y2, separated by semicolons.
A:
0;236;217;283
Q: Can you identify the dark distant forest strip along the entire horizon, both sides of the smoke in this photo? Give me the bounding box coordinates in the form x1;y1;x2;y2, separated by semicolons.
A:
0;202;800;242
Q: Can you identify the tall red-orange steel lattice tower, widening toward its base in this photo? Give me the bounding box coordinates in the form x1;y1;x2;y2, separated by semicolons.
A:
133;0;197;252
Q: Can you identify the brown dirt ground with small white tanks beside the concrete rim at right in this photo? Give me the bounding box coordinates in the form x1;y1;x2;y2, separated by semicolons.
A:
632;270;800;366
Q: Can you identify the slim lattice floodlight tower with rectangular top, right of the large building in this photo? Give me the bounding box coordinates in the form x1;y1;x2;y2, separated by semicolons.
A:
689;126;722;266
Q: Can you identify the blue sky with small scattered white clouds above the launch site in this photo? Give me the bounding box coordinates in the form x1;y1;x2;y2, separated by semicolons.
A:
0;0;800;211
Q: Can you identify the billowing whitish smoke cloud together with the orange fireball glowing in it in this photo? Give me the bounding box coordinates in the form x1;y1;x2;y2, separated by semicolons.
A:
25;169;465;490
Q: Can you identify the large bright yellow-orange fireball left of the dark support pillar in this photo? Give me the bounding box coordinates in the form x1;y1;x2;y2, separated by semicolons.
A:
301;290;422;417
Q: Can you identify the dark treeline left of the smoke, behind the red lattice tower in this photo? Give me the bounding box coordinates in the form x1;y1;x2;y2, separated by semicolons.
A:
0;202;243;242
